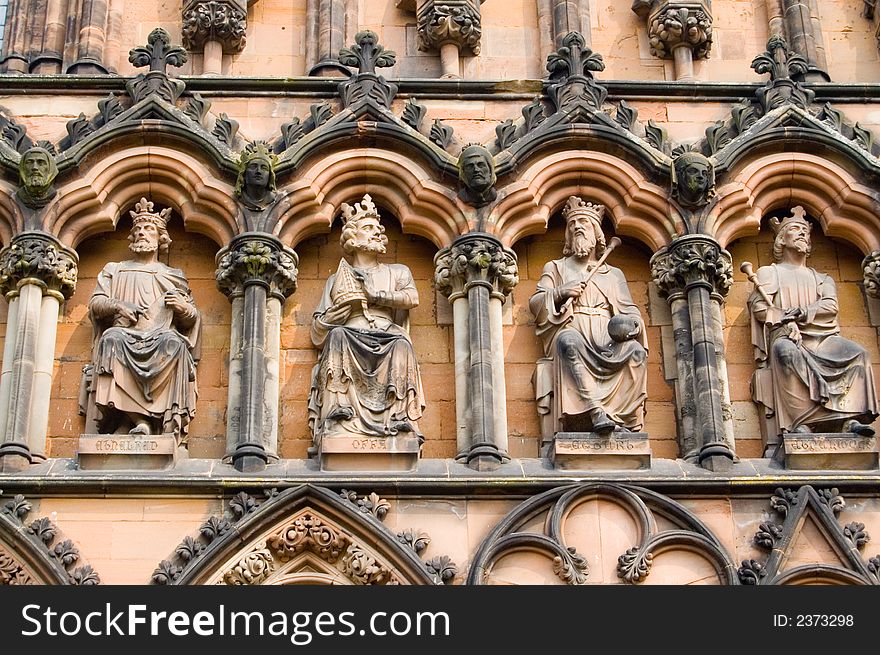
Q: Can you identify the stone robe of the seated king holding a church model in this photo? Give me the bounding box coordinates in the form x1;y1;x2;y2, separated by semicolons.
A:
308;264;425;447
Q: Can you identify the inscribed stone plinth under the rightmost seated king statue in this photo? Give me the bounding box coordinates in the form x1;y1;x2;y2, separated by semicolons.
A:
782;432;878;471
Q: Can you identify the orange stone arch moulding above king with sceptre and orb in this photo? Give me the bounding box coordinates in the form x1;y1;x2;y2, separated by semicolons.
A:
489;150;678;251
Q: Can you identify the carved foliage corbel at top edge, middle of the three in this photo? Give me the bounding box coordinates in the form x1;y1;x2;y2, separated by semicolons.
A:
416;0;482;55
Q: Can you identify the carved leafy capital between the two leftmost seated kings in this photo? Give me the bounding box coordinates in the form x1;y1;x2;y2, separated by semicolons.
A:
216;232;299;302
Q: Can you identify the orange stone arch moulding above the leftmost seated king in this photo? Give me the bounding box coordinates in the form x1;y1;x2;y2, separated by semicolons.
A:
45;146;241;247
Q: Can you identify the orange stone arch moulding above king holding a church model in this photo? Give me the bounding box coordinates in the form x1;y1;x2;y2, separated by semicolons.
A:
275;148;467;248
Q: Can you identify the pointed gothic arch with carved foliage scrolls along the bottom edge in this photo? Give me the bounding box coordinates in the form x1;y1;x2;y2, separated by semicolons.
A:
168;484;436;585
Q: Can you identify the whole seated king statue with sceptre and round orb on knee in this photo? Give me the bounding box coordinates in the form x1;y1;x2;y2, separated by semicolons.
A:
529;196;647;446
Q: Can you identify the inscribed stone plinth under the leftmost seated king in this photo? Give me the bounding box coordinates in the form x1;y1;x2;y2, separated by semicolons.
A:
77;434;177;471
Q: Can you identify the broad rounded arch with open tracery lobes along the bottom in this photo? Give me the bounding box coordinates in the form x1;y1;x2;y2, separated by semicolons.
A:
467;482;738;584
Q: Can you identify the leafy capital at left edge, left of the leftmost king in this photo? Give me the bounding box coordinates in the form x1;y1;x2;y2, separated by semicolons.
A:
0;232;79;302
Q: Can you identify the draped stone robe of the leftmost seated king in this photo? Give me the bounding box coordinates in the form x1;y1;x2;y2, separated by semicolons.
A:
89;261;201;443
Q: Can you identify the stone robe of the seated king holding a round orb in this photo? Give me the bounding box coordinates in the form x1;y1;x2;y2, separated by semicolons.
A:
529;259;647;442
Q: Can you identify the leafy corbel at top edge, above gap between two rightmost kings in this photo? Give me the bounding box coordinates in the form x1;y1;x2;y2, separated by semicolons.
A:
647;0;712;59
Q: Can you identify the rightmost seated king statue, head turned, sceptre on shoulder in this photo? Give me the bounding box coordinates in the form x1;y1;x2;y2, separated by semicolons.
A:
744;207;877;448
